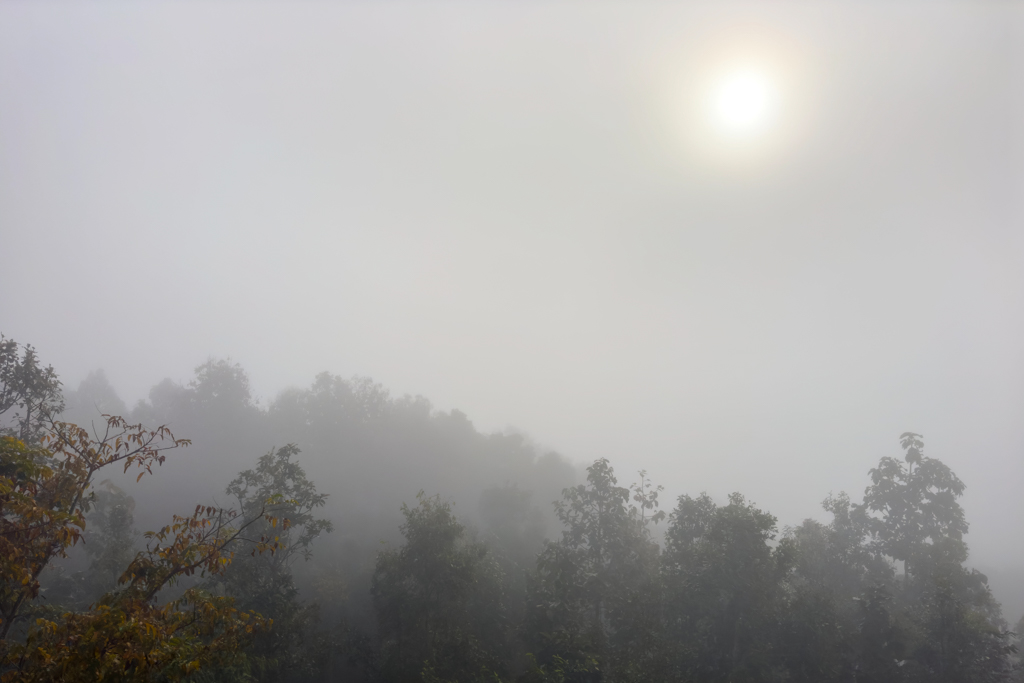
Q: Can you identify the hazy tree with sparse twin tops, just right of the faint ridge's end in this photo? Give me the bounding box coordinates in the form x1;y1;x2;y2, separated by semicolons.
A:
525;459;665;680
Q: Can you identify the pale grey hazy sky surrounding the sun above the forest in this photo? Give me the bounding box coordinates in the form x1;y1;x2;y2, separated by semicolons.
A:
0;2;1024;602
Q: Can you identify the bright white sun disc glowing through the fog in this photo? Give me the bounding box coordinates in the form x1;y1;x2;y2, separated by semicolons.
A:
709;68;778;137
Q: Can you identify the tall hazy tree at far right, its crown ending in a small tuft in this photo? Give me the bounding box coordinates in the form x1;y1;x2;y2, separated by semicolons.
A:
856;432;1013;683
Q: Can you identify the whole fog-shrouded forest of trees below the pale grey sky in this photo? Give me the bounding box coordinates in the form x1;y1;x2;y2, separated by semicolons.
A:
0;338;1024;683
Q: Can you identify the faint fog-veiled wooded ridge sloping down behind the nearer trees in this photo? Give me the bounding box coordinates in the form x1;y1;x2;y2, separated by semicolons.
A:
61;360;580;593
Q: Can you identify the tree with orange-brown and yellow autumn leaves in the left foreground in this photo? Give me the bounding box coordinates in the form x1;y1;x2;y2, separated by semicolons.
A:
0;397;288;683
